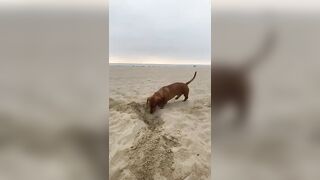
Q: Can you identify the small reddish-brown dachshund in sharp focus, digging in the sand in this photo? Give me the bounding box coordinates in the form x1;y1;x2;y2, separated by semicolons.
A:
147;72;197;114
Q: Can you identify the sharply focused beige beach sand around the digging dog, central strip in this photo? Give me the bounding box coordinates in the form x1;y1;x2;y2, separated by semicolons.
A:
109;66;211;180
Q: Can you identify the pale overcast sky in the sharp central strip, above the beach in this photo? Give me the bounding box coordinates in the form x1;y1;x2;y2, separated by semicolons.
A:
109;0;211;64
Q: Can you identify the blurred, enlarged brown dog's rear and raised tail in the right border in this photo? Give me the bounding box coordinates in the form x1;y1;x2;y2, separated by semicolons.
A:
211;30;275;124
